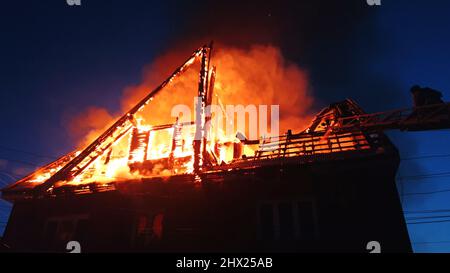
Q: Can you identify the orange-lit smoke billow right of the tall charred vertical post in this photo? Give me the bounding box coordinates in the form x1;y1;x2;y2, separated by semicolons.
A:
215;45;314;131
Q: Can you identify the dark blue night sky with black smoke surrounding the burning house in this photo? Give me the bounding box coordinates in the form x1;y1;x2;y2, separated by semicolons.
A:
0;0;450;252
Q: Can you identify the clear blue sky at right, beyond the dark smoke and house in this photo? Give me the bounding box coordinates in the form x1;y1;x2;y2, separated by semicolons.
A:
375;1;450;252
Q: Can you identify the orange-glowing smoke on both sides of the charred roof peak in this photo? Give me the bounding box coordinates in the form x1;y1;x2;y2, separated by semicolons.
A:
69;45;313;144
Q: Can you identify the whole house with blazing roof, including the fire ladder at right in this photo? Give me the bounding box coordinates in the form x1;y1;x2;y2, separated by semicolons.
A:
2;46;450;252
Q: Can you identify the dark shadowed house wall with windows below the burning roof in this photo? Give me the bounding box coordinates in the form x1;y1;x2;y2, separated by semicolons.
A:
0;152;411;252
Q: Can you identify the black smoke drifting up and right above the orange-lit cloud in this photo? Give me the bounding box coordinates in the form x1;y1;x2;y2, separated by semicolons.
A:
165;0;407;111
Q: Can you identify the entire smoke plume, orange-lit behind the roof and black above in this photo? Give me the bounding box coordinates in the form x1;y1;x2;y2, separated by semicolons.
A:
65;0;384;146
